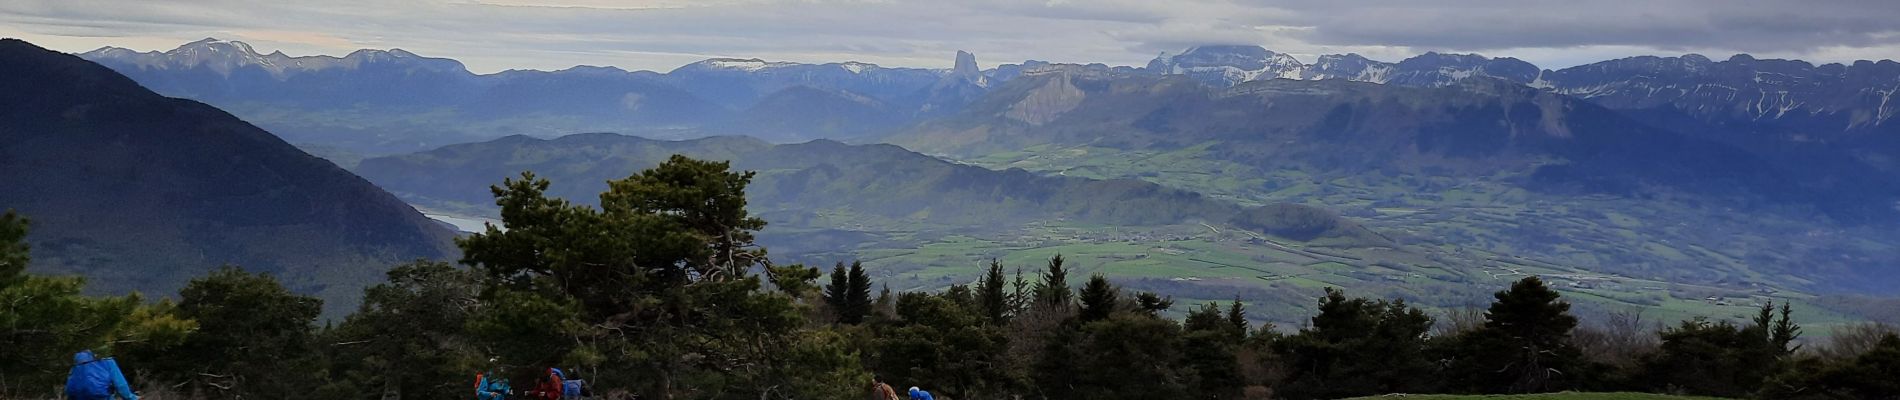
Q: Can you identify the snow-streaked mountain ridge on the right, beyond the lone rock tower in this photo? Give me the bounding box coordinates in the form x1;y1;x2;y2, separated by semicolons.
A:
1146;45;1900;150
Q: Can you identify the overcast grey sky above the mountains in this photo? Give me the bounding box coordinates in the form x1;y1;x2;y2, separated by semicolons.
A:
0;0;1900;72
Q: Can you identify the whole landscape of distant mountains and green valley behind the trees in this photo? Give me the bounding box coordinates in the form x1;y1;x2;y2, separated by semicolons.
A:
18;40;1900;324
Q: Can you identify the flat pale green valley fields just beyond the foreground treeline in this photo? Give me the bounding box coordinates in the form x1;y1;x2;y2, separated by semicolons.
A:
744;214;1860;337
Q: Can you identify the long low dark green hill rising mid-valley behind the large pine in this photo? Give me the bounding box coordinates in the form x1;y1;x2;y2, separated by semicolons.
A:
357;135;1239;227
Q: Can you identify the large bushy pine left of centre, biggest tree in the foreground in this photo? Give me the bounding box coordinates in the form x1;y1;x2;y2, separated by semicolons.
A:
456;155;863;398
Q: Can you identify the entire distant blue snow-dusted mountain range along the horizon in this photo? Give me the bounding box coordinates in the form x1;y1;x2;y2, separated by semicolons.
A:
82;40;1900;173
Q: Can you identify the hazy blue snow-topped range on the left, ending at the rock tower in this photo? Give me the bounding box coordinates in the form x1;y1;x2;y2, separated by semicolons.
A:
80;38;982;155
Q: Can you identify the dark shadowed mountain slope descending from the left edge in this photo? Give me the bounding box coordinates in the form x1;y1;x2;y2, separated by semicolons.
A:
0;40;456;311
